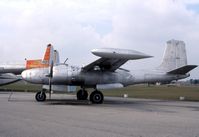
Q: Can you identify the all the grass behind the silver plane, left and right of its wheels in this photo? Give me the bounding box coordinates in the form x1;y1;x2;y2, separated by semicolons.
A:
0;82;199;101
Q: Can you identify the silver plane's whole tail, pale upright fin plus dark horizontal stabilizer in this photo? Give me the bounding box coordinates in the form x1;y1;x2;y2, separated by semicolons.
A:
158;40;197;74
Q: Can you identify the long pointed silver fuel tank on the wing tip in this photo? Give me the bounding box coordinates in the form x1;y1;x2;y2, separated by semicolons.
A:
91;48;152;60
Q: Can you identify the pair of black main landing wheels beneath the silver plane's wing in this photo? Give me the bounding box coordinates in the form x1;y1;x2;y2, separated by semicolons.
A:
77;89;104;104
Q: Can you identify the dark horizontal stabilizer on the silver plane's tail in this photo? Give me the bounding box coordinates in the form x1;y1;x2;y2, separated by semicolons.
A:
167;65;197;75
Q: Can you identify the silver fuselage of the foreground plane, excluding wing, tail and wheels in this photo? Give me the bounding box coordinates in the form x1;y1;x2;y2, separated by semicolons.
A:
22;64;189;87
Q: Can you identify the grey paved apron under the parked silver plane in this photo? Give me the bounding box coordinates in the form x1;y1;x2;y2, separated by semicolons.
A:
0;92;199;137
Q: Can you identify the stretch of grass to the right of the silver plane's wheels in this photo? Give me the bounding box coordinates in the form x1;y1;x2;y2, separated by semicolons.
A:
103;85;199;101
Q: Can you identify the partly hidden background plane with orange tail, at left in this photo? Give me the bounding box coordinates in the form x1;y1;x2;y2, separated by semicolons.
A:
0;44;59;86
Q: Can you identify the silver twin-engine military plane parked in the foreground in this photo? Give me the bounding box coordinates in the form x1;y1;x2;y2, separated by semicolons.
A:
22;40;197;104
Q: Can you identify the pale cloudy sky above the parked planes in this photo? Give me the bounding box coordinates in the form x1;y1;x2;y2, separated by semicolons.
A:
0;0;199;78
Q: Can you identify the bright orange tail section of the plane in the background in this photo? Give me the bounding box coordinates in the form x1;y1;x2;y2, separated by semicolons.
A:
26;44;54;69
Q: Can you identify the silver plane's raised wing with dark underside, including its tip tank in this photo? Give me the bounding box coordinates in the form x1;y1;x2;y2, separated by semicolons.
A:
83;48;151;72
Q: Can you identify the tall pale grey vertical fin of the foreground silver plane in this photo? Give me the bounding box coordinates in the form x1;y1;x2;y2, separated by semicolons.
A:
158;40;187;72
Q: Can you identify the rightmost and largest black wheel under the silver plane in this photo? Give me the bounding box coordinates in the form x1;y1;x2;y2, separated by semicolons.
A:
90;90;104;104
